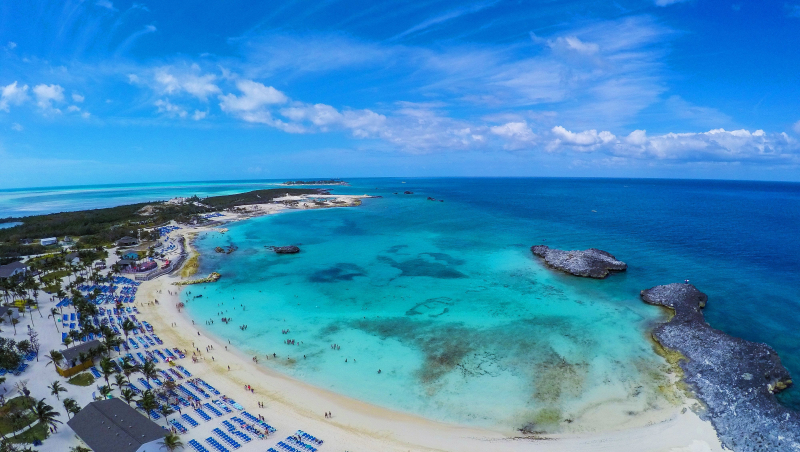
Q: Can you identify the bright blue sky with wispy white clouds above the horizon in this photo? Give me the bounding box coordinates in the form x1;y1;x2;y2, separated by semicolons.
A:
0;0;800;188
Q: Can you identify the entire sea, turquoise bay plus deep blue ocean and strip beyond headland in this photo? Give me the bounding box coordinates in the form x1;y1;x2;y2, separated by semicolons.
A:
0;178;800;428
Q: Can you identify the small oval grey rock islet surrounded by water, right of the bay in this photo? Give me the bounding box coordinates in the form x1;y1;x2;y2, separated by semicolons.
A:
531;245;628;278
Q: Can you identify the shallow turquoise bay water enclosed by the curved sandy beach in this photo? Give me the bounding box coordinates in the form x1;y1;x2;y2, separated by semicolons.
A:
184;182;708;430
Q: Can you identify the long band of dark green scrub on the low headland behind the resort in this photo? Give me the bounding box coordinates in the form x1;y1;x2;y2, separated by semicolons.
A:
0;188;321;258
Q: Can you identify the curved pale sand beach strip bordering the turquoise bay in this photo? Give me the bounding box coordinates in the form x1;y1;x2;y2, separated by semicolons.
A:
126;196;722;451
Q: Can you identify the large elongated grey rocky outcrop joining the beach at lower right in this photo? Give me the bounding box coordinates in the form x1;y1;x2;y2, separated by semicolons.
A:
641;284;800;452
